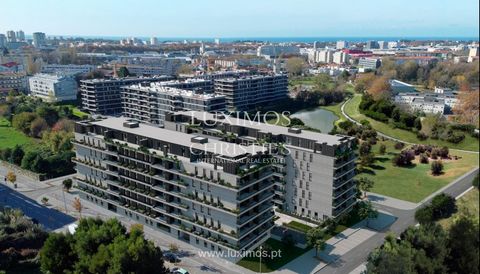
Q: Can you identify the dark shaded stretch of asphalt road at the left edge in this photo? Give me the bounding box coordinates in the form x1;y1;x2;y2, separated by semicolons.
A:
0;183;75;231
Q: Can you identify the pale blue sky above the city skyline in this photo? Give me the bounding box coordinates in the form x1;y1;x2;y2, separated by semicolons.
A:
0;0;479;37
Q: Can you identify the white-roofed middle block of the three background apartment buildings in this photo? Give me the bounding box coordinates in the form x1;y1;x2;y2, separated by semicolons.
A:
122;82;225;125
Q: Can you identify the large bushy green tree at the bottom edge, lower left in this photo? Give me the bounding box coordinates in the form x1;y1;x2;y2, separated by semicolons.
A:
40;218;167;274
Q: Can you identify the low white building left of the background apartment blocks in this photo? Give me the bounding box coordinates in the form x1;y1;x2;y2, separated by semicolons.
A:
28;73;77;102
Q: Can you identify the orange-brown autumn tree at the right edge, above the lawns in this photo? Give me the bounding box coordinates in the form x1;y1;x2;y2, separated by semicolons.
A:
453;90;480;127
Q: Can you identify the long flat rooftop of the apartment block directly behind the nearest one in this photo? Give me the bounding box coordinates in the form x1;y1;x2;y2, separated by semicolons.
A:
176;111;351;146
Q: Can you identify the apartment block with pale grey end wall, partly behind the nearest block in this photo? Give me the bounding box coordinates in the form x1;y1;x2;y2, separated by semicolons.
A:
165;111;357;220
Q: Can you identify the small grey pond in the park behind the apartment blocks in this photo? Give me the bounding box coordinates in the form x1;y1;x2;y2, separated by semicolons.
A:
290;107;339;133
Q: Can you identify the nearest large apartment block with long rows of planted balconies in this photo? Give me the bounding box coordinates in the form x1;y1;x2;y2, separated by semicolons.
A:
73;117;274;260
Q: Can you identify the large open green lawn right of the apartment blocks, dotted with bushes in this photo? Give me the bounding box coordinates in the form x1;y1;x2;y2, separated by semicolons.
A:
357;141;479;203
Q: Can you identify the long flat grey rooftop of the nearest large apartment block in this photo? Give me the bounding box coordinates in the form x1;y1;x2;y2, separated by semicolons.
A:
91;117;267;158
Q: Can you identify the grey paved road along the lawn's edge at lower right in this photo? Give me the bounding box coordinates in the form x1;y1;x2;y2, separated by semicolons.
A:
316;169;478;274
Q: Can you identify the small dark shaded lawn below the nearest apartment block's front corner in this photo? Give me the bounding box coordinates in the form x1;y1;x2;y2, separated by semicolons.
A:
237;238;309;273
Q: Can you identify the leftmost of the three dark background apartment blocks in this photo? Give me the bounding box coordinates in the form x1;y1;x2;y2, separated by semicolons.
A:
80;76;172;115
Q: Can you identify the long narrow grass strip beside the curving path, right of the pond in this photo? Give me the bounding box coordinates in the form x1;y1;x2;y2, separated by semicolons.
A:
345;94;479;151
